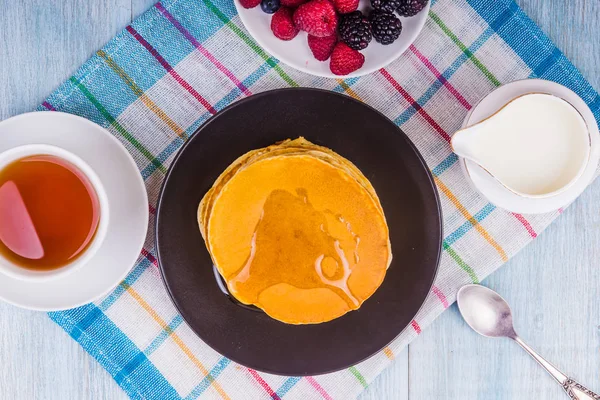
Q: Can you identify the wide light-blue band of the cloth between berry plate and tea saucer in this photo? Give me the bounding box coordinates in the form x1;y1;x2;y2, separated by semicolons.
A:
40;0;236;119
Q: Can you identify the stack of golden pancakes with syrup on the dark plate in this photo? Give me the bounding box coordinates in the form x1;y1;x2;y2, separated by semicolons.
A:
198;138;392;324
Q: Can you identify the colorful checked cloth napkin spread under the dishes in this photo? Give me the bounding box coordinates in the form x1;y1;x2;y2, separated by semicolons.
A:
41;0;600;400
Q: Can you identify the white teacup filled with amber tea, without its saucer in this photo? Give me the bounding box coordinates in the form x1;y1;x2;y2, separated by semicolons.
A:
0;144;109;280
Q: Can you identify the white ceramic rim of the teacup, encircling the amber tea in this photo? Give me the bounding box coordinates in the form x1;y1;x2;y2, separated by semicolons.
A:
0;144;109;281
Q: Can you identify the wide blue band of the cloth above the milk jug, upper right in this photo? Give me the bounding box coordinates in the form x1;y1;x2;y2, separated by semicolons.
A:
467;0;600;121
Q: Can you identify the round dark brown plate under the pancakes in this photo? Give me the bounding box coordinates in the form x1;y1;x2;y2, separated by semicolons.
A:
156;89;442;376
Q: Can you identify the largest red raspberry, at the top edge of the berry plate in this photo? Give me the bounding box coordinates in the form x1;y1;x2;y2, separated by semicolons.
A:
294;0;338;37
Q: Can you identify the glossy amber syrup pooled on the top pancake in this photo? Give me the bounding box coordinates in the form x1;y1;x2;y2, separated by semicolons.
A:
226;189;360;309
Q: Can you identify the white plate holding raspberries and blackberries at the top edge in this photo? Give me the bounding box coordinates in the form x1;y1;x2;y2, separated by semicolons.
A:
234;0;429;78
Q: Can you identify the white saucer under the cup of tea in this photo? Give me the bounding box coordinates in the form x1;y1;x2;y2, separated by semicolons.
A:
0;112;148;311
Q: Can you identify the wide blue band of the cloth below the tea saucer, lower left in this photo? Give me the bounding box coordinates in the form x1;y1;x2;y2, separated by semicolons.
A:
49;304;181;400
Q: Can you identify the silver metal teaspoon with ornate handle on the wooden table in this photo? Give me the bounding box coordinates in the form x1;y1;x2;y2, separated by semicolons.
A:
456;285;600;400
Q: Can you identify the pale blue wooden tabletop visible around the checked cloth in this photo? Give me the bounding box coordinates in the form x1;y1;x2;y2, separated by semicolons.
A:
0;0;600;400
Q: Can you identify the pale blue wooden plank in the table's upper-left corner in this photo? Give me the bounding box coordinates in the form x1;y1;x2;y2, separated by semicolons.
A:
0;0;131;119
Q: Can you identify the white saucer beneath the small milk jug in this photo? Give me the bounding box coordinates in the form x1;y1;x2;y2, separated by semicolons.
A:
459;79;600;214
